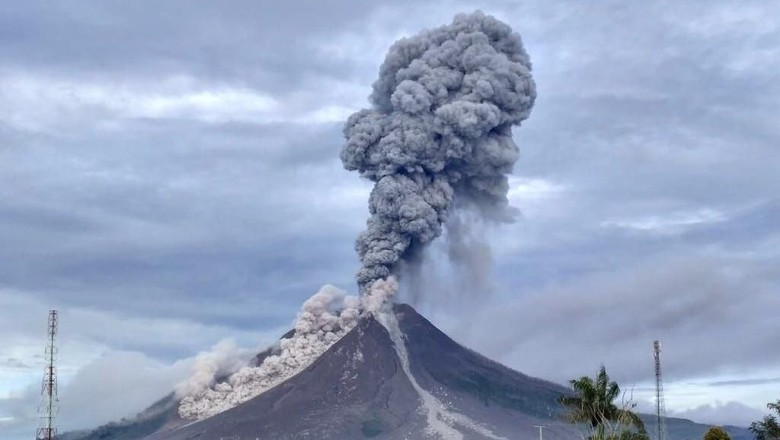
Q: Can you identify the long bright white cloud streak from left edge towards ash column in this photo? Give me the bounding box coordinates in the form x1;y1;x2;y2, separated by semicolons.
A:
0;71;360;132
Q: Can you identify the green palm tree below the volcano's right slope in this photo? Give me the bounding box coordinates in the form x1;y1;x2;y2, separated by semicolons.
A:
560;365;645;440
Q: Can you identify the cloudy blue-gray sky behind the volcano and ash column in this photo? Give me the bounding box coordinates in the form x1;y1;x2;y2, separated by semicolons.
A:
0;0;780;440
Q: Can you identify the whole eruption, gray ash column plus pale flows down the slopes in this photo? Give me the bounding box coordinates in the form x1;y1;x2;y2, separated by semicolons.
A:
179;12;536;422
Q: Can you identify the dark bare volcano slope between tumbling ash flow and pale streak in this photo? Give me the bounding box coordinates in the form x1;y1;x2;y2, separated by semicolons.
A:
148;312;422;440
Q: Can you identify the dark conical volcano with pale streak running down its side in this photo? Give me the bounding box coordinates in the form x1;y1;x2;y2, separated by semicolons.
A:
68;304;760;440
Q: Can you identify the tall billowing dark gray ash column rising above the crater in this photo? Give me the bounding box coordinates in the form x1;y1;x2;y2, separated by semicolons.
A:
341;11;536;292
